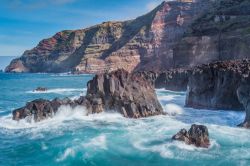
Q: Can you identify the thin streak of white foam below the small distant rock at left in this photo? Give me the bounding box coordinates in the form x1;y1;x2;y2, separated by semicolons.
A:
26;88;87;94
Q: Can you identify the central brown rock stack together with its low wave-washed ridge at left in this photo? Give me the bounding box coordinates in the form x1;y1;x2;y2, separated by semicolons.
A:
13;70;164;122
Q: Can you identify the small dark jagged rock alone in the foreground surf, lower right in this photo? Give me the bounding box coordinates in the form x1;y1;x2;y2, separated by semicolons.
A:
172;124;210;148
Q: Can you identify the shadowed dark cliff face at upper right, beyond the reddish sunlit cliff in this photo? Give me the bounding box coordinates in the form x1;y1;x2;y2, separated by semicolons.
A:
174;0;250;67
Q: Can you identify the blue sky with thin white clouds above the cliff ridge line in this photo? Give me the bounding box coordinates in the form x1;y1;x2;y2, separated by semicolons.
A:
0;0;163;56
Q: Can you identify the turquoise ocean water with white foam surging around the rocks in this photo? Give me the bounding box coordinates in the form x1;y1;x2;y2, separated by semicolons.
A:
0;73;250;166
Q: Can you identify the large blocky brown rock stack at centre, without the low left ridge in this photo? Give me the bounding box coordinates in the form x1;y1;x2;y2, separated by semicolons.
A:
86;70;163;118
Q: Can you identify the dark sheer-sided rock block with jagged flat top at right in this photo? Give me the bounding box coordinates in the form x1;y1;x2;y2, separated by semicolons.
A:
186;60;250;110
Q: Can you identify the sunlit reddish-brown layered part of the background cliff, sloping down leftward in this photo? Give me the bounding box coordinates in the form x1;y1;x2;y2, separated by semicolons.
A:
6;0;211;73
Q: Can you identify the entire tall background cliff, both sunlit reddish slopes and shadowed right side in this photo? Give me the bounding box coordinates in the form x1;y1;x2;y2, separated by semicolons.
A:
6;0;250;73
